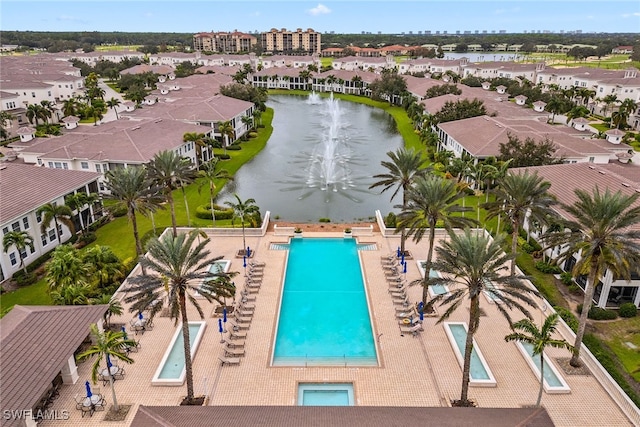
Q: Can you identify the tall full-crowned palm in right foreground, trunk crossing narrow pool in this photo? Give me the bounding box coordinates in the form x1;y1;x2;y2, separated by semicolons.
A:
429;228;539;406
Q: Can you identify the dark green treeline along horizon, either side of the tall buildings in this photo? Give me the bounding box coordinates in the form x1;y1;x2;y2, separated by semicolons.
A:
0;31;640;52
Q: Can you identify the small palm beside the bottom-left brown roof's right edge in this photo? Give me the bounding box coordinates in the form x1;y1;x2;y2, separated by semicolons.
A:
78;323;136;411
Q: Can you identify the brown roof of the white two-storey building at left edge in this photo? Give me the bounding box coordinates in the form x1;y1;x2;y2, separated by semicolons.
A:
0;162;100;223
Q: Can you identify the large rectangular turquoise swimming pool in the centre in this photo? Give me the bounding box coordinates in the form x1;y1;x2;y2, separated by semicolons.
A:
272;238;378;366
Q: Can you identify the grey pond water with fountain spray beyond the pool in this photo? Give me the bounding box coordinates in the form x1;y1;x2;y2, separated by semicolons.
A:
220;94;403;222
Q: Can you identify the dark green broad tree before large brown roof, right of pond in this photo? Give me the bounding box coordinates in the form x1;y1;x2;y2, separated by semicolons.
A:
498;133;563;168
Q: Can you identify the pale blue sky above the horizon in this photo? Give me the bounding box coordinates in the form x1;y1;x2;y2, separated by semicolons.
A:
0;0;640;34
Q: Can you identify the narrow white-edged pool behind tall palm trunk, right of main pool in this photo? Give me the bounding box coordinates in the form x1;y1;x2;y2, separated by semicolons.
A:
444;322;497;387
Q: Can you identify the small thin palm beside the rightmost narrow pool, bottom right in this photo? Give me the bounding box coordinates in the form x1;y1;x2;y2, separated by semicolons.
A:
504;313;573;408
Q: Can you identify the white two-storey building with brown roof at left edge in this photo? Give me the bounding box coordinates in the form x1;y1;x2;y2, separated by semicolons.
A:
0;161;102;282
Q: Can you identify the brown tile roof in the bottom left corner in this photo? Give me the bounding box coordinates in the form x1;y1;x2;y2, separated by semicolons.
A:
0;304;108;426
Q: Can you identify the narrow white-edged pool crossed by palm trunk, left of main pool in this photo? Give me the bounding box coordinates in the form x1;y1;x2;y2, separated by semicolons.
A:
151;321;207;386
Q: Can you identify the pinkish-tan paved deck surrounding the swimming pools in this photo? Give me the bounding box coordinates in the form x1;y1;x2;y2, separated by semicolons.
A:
42;231;632;427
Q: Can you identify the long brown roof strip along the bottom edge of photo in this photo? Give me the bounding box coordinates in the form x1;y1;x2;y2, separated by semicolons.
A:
131;406;554;427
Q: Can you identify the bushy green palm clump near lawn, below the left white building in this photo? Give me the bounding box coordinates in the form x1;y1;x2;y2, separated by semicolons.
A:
44;245;91;290
